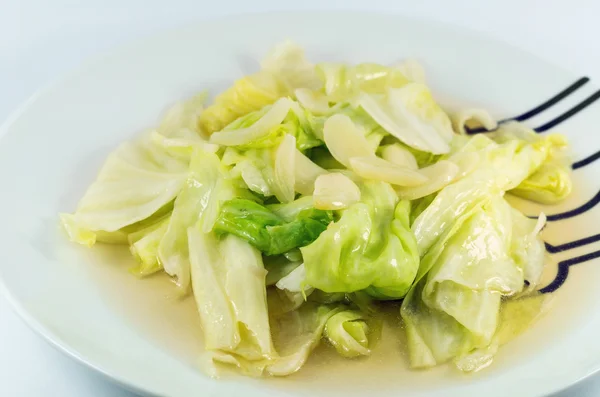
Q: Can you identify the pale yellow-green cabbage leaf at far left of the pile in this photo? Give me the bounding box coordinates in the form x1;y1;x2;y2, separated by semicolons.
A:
61;96;217;246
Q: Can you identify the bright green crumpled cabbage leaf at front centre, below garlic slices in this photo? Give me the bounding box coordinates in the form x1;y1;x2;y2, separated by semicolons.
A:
300;182;419;299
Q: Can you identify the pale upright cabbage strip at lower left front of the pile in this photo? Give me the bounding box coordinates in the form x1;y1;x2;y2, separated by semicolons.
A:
188;226;276;360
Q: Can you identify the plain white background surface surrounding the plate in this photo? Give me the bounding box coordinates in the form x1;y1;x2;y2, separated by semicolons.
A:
0;0;600;397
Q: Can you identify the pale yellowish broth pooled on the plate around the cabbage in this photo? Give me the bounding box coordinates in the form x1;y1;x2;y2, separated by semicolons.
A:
81;190;600;395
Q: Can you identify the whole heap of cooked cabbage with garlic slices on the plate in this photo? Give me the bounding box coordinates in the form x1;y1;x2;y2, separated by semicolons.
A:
60;42;572;376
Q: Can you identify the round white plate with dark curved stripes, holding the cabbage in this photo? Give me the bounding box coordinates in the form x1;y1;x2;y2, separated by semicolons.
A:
0;12;600;397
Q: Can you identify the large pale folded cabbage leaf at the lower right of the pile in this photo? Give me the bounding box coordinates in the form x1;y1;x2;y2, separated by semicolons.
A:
401;196;543;367
